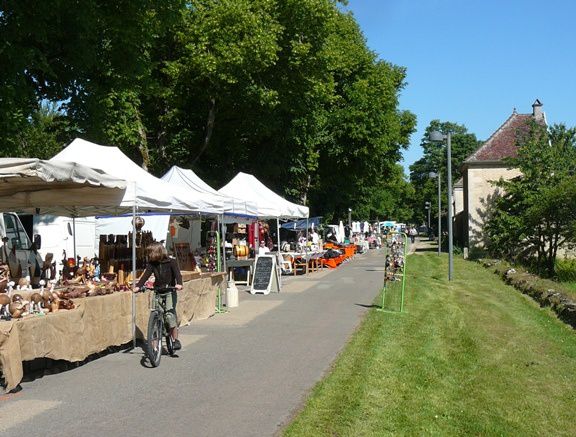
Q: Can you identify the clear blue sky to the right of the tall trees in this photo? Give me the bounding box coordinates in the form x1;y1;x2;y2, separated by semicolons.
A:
346;0;576;174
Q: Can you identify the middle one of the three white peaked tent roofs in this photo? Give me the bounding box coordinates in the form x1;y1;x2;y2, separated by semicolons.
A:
162;165;258;217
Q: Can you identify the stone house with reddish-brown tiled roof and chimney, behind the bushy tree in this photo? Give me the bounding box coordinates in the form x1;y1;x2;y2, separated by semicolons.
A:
455;100;546;256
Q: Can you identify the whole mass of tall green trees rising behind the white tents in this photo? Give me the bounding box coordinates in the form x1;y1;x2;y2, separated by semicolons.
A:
0;0;416;220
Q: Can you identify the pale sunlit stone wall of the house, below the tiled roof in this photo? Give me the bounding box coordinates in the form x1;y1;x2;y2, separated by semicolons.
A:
468;167;520;250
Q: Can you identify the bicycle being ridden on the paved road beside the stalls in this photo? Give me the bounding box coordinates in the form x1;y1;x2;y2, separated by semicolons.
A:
146;287;176;367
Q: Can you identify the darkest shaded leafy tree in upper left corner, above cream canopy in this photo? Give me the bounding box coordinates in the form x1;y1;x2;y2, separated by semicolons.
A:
0;0;185;162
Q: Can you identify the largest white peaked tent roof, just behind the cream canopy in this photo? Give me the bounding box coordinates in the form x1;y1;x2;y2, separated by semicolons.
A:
50;138;224;214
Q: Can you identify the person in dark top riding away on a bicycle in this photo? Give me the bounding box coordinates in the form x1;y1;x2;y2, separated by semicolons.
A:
134;243;182;350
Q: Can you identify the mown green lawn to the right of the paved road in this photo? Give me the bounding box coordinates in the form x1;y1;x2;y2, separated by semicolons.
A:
285;254;576;436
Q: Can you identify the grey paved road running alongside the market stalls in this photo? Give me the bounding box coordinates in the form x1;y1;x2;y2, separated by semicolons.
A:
0;250;383;437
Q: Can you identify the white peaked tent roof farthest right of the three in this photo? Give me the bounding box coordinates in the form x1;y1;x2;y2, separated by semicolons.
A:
218;172;309;218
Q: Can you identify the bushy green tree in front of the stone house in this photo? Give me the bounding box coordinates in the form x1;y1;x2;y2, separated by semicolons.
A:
485;123;576;276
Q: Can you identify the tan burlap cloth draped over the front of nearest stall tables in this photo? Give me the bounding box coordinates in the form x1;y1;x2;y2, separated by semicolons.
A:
0;272;225;391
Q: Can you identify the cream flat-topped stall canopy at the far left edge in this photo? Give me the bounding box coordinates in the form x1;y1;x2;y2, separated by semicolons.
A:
0;158;126;217
